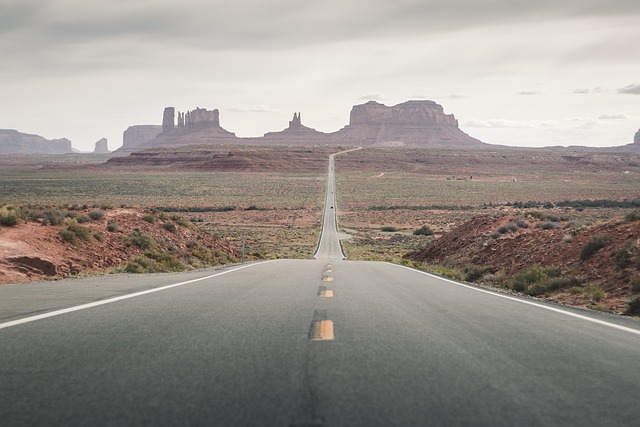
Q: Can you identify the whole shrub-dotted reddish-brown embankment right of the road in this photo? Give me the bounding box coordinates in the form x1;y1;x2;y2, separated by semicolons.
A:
406;211;640;314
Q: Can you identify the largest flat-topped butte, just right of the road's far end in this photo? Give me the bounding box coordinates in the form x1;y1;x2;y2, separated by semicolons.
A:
333;101;486;147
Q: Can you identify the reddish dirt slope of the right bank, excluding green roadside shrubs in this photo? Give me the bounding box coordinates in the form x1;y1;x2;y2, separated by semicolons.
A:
406;215;640;313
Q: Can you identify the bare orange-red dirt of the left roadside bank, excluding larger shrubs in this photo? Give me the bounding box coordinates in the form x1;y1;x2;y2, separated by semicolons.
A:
0;209;236;284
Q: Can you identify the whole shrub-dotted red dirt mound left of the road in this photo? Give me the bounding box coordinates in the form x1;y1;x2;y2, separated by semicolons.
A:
0;206;237;284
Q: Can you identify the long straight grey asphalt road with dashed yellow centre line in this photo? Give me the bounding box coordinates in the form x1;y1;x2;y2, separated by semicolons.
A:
0;152;640;426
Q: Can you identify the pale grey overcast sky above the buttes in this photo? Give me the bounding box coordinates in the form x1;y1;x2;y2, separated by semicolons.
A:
0;0;640;151
